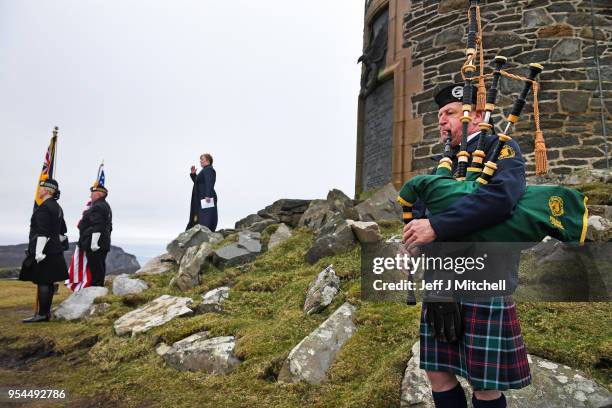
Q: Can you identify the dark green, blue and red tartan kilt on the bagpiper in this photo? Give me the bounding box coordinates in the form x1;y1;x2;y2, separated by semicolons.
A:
420;296;531;391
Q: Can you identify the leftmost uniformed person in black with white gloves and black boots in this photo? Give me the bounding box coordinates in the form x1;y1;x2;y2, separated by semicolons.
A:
19;179;68;323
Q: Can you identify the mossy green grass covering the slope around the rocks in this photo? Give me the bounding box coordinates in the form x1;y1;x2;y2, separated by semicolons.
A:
0;228;612;407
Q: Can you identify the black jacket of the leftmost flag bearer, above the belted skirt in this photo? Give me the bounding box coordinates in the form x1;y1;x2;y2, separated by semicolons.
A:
28;198;66;255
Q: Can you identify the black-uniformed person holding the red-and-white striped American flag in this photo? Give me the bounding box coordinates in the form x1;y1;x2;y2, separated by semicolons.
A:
79;183;113;286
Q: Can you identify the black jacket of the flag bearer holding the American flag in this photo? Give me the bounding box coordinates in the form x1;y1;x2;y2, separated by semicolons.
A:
79;198;113;251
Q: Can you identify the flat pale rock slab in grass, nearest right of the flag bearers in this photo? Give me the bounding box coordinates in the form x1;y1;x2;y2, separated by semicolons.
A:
114;295;193;336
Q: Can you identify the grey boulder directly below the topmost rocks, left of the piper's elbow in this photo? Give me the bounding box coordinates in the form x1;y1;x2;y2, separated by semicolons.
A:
306;216;355;264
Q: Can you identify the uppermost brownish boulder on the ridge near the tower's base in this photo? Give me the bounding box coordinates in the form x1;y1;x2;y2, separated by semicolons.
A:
298;189;359;232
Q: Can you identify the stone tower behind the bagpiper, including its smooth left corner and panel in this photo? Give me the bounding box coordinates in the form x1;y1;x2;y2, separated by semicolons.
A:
355;0;612;195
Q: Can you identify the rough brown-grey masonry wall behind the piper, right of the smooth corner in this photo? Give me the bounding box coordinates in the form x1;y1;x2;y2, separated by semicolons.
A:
403;0;612;174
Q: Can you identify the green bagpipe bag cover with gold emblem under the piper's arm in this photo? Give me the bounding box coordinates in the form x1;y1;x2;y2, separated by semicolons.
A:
399;174;588;244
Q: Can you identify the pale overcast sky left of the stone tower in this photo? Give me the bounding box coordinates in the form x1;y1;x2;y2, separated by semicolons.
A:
0;0;364;255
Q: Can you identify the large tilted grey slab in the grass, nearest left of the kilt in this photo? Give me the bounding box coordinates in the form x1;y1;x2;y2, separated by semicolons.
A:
278;303;357;384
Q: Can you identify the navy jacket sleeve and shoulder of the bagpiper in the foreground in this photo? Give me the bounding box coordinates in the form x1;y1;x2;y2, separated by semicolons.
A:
413;135;525;242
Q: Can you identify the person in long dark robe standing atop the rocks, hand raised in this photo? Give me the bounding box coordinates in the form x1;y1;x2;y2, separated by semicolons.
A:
186;153;218;231
